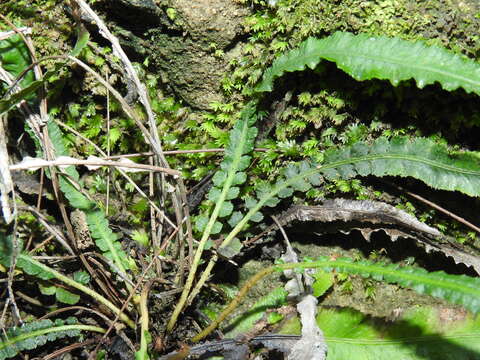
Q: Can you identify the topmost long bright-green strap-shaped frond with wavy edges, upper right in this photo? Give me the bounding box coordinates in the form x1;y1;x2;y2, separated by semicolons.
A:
255;32;480;95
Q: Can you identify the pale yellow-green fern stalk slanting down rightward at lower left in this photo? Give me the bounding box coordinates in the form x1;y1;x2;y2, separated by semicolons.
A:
18;254;135;329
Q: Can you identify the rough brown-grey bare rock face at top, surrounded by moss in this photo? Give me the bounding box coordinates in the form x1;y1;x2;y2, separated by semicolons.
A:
108;0;249;109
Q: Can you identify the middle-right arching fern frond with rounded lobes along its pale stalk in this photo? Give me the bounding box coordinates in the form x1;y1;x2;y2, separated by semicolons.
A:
221;137;480;247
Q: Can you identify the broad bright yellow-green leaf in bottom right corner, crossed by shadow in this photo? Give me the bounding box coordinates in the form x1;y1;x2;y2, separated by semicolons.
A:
278;307;480;360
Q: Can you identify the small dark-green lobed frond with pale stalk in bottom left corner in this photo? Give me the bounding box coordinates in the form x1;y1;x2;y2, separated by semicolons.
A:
0;317;105;360
